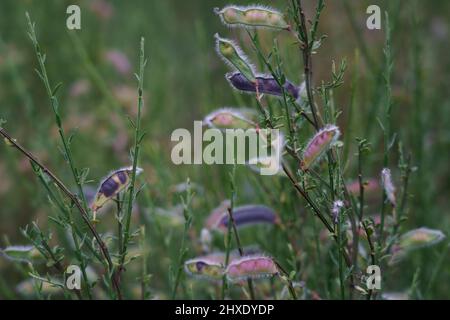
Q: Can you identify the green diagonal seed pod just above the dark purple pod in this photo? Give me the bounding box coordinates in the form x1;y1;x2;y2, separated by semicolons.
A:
214;33;255;81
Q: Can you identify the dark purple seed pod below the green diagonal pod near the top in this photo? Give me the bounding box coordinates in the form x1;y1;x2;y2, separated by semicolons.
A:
225;72;303;101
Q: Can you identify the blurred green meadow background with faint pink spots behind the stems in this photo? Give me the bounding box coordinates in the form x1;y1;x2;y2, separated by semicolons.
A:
0;0;450;298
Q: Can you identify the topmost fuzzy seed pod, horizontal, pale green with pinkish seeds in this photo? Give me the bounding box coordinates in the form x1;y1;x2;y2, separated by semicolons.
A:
214;6;290;30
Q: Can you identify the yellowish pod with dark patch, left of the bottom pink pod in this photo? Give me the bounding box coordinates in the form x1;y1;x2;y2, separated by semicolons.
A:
184;253;225;280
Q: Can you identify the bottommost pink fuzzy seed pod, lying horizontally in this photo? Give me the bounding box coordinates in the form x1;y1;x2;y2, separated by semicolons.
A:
225;255;280;282
